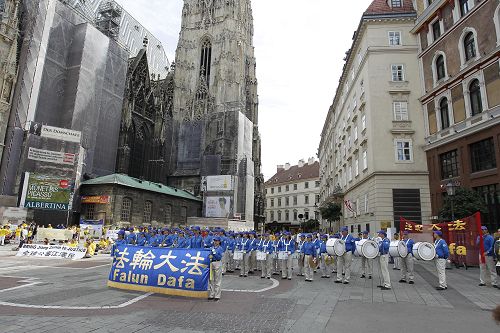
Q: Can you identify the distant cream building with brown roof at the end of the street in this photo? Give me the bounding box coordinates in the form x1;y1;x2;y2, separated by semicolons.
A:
264;157;320;230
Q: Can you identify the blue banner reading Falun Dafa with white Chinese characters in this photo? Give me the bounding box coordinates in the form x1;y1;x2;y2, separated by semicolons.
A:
108;245;210;298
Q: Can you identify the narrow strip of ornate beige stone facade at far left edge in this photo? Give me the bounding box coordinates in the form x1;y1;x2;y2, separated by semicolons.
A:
0;0;19;160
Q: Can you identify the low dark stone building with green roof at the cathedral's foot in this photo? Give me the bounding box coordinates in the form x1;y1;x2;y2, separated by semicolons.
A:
81;174;202;227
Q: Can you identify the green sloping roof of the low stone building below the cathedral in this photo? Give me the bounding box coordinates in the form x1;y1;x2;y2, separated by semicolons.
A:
82;174;201;201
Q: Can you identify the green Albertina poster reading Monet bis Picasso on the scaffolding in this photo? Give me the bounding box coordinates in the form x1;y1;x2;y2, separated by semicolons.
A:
21;172;71;210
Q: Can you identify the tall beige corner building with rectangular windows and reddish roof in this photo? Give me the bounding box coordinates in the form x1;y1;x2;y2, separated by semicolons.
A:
319;0;430;233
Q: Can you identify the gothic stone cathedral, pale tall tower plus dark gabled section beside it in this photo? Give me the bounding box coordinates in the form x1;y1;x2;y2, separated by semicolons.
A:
117;0;264;223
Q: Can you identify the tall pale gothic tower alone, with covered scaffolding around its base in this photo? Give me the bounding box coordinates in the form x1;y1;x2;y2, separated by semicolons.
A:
169;0;261;221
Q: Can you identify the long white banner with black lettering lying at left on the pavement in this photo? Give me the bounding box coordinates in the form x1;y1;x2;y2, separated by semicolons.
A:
16;244;87;260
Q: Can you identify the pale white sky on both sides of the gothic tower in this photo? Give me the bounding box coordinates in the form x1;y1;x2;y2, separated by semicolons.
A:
117;0;372;180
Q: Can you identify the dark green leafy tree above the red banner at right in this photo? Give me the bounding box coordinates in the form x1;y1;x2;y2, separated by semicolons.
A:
439;187;488;221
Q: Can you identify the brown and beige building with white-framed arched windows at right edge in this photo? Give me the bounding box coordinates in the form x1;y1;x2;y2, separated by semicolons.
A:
413;0;500;231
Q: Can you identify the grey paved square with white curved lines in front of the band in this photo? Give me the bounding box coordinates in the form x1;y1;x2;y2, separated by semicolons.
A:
0;251;500;333
